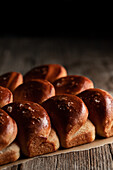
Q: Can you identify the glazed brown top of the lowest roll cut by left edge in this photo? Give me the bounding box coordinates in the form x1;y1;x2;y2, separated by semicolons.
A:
0;109;17;151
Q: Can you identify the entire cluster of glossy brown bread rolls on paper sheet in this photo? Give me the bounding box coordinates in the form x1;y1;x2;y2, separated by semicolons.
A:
0;64;113;165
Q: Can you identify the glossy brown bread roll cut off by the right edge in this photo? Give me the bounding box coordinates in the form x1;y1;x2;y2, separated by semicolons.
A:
78;89;113;137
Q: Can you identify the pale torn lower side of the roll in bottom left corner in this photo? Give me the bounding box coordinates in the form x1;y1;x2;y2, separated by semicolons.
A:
0;142;20;165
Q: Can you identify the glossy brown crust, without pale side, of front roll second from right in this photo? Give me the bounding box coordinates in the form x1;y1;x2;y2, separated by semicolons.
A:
42;95;88;146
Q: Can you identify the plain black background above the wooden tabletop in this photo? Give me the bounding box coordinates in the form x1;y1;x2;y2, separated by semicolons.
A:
0;0;113;40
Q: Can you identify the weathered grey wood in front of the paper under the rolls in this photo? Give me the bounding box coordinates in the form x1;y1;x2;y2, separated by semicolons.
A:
4;145;113;170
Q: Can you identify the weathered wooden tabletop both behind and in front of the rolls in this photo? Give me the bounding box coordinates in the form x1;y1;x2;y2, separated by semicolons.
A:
0;38;113;170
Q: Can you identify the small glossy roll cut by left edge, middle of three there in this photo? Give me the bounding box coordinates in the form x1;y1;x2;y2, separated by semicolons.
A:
0;86;13;108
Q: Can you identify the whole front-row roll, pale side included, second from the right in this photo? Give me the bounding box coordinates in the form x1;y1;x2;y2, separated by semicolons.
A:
42;95;95;148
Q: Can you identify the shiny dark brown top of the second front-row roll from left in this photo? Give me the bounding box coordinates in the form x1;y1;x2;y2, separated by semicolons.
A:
3;101;51;138
